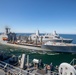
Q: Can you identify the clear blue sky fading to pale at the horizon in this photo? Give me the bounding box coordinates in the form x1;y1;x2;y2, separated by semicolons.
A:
0;0;76;34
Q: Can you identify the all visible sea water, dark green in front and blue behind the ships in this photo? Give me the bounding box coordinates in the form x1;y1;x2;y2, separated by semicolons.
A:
0;33;76;65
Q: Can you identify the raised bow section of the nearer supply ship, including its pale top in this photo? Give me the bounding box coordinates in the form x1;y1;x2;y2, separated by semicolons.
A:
41;41;76;53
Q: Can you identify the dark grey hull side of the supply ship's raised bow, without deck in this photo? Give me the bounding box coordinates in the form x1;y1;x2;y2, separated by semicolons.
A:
41;45;76;53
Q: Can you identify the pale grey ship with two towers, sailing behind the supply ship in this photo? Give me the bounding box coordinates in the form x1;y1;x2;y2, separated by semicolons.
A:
29;30;73;43
